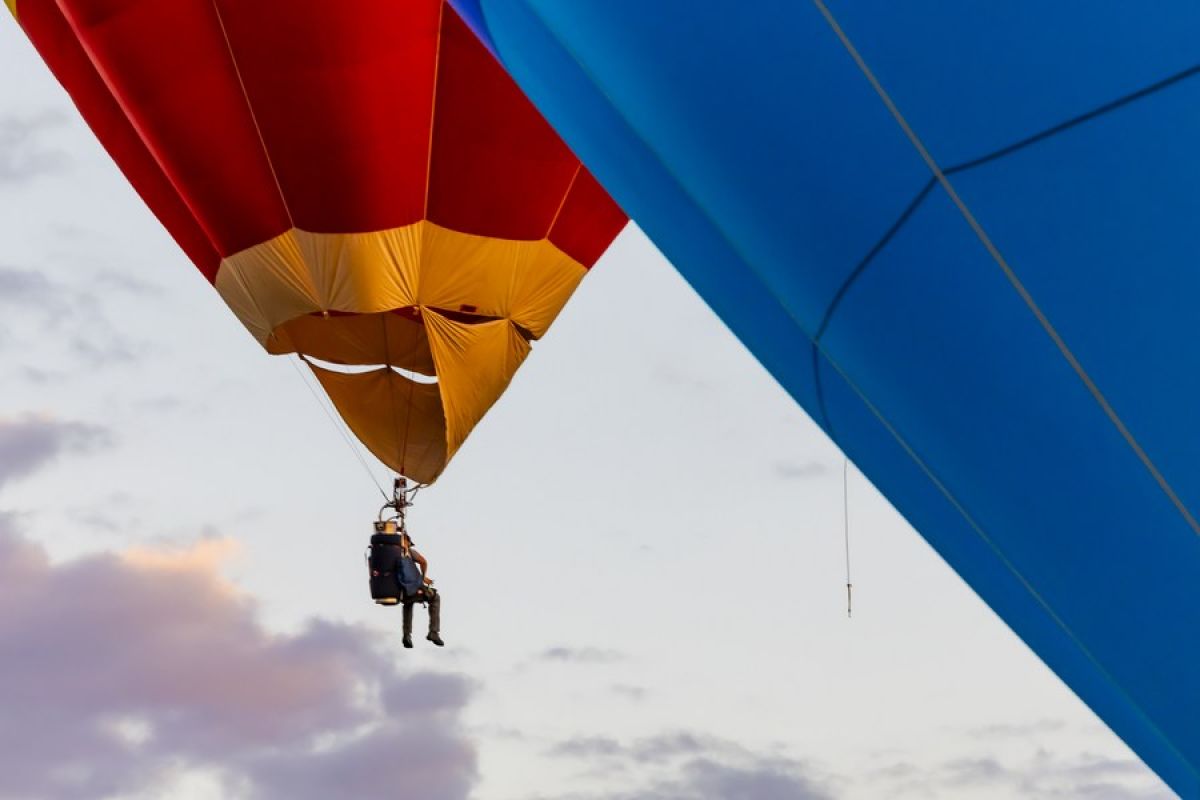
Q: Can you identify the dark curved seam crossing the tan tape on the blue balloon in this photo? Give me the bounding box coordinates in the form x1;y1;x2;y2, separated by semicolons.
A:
812;65;1200;438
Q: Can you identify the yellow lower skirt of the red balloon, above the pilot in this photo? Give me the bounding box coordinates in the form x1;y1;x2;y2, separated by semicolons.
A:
216;221;587;482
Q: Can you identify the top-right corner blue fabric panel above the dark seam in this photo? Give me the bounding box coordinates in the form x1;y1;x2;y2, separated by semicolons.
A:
820;0;1200;168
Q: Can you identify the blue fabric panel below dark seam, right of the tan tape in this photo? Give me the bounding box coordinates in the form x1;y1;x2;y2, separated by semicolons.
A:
954;79;1200;513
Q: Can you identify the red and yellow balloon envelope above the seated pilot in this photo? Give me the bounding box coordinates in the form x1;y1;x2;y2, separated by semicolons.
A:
6;0;626;483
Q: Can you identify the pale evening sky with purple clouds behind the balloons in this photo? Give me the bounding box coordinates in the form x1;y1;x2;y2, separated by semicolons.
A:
0;18;1172;800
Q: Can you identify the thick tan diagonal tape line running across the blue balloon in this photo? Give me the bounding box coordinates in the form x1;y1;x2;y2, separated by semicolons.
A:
812;0;1200;544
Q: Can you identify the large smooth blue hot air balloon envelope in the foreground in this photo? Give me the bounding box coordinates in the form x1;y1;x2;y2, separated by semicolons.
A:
455;0;1200;798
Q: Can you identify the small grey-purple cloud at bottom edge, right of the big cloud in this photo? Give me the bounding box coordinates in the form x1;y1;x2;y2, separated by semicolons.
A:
548;732;834;800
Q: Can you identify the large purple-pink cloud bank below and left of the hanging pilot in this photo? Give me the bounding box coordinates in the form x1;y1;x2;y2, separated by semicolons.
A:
0;516;478;800
